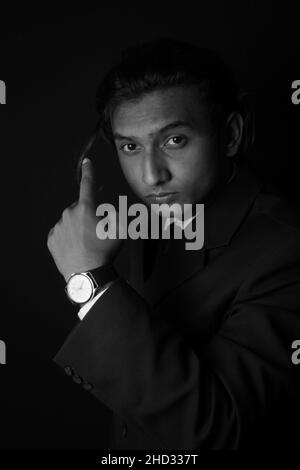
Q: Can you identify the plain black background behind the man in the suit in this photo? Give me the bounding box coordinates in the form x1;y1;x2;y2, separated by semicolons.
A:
0;0;300;449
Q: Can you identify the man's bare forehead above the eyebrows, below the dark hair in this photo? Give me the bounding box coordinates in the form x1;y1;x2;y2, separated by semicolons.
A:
111;86;207;137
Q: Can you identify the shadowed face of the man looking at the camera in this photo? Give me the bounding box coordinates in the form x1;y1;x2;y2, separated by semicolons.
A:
112;86;229;216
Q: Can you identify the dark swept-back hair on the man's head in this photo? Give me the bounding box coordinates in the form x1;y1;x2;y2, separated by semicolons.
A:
76;38;254;179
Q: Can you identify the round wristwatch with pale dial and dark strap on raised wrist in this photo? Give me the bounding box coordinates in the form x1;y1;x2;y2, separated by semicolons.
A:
65;264;118;305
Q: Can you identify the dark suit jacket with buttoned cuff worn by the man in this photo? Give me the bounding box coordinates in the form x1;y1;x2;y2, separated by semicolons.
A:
54;169;300;450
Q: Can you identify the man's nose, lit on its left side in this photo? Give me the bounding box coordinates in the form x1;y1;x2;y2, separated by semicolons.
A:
143;151;170;187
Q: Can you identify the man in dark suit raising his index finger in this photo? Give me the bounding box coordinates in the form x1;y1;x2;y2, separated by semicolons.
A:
48;40;300;450
